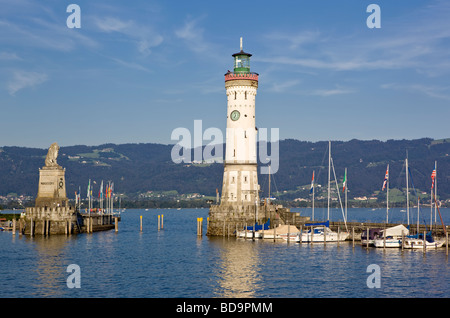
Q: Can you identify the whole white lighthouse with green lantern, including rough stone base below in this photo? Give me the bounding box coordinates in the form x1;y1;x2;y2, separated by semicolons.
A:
207;38;269;236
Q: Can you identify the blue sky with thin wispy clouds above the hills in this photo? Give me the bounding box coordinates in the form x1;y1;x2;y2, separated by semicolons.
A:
0;0;450;148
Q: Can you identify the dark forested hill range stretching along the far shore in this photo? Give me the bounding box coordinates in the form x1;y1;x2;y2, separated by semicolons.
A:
0;138;450;199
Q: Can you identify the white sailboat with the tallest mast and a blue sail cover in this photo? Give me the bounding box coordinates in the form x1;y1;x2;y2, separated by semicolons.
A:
295;141;350;243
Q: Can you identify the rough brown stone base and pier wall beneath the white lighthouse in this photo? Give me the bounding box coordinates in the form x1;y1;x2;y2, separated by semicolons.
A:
206;204;301;236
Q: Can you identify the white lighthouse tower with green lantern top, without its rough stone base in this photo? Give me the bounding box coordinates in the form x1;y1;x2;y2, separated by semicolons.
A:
221;38;259;205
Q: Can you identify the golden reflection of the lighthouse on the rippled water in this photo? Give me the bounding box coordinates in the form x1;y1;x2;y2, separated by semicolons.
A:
210;238;262;298
